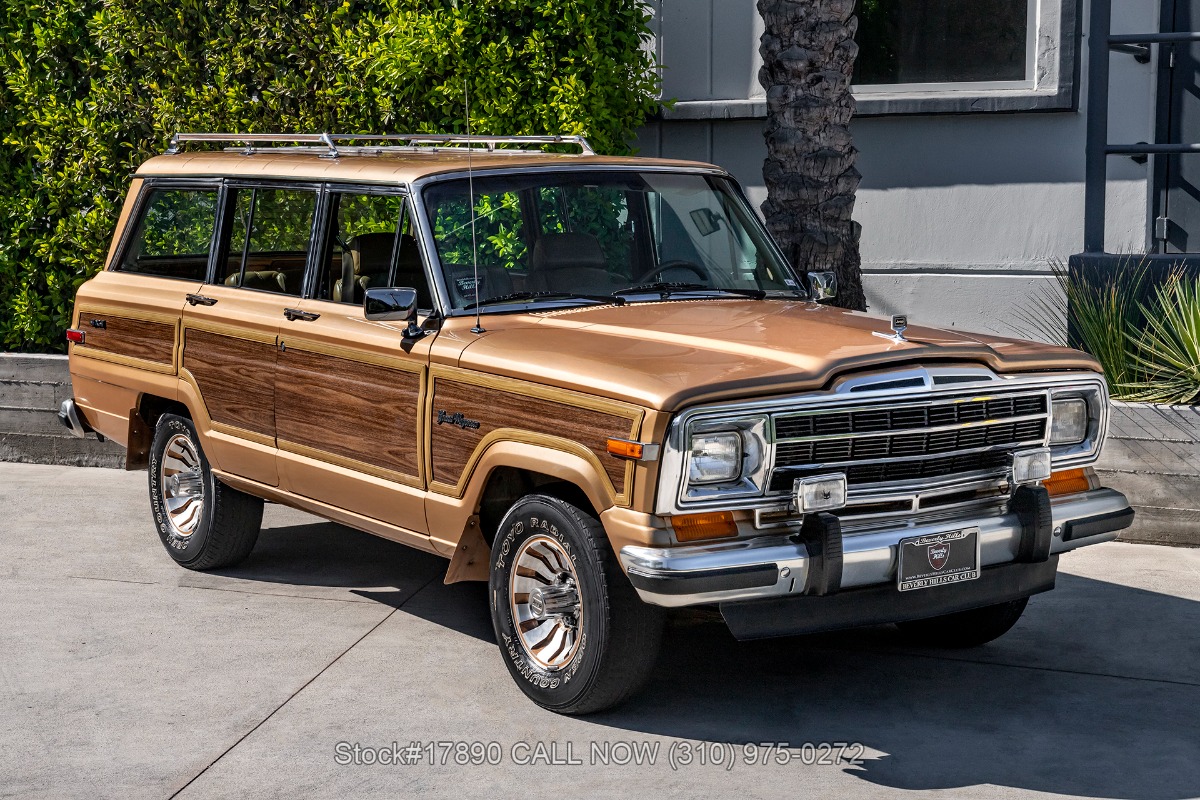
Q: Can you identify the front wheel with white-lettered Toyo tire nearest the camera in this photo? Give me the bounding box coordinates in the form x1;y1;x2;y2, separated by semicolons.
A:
488;494;664;715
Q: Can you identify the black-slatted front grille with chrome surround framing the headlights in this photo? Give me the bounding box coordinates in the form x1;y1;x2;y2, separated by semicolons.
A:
654;365;1109;515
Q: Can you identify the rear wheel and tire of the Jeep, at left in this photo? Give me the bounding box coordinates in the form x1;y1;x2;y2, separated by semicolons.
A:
149;414;263;570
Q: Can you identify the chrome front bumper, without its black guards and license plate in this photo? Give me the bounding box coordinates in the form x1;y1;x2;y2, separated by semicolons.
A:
620;488;1133;607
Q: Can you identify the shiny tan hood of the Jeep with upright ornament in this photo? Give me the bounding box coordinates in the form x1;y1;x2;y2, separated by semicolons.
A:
458;299;1099;411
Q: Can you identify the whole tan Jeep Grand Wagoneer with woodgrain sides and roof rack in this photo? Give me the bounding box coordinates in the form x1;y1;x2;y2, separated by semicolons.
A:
61;134;1133;714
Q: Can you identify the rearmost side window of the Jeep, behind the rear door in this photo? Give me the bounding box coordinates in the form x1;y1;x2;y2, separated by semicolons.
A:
116;188;217;281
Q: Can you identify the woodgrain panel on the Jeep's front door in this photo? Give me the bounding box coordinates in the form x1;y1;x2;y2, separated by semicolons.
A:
275;339;421;477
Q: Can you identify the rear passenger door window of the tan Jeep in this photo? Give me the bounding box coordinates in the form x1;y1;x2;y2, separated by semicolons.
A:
217;188;317;296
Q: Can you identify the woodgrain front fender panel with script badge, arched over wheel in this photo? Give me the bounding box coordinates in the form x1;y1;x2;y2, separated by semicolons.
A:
430;378;631;492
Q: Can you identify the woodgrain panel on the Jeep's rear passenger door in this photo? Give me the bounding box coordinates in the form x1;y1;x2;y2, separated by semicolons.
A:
184;327;276;438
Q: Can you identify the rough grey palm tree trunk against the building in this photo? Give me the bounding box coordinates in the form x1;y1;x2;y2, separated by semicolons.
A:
758;0;866;311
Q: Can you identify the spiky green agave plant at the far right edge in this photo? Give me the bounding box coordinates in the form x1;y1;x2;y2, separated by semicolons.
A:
1126;271;1200;405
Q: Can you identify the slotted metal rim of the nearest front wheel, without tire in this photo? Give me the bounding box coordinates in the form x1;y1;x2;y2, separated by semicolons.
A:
509;536;583;669
